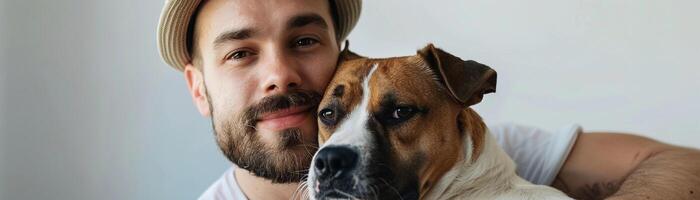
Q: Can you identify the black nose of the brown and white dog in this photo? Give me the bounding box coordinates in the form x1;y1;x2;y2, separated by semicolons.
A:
314;146;358;178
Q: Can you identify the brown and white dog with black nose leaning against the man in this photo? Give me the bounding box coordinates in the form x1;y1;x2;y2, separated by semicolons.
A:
307;43;570;199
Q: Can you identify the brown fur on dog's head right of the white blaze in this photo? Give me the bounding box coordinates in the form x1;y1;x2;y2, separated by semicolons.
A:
370;57;473;197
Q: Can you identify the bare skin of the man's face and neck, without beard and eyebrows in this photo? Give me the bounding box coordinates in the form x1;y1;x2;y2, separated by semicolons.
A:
184;0;339;199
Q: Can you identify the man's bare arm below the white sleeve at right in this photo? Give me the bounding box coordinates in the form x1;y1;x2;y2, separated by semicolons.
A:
552;133;700;200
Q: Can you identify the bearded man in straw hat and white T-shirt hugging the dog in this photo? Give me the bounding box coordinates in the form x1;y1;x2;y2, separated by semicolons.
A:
158;0;700;199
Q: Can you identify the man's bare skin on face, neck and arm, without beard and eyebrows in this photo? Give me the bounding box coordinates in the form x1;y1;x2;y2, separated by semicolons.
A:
184;0;700;199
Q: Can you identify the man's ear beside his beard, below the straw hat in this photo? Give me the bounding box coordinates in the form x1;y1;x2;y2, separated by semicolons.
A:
183;63;211;117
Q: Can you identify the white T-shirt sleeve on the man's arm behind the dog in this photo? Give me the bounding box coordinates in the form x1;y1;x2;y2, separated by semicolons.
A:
490;124;582;185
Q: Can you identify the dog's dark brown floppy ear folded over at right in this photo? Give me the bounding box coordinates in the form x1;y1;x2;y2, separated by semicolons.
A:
418;44;496;107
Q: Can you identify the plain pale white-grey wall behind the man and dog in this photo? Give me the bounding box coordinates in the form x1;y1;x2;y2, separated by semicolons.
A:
0;0;700;199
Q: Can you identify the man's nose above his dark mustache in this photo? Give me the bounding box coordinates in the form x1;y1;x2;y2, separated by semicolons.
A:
262;53;303;93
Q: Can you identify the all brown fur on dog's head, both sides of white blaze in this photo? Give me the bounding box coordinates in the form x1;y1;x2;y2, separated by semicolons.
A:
319;52;486;199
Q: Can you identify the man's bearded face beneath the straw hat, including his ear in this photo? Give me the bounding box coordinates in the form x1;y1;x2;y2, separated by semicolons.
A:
185;0;339;183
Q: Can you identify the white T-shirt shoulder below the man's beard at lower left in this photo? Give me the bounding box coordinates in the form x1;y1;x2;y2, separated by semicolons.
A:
199;166;247;200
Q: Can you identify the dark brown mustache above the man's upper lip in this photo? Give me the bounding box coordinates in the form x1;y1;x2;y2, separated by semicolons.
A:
243;89;321;127
